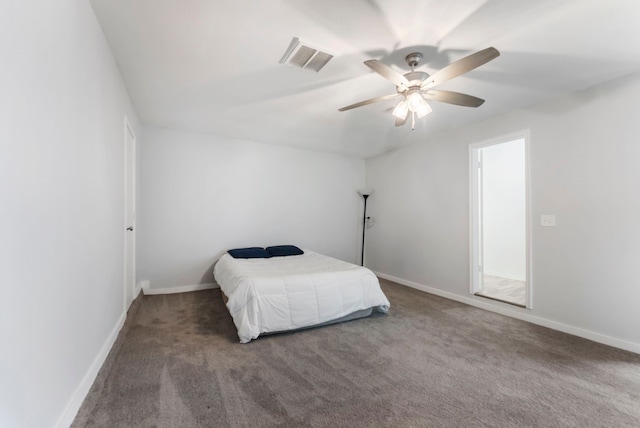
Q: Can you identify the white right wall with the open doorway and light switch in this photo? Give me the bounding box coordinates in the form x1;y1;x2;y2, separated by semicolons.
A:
367;75;640;352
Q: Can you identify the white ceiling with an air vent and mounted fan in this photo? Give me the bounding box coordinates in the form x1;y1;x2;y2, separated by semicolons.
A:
91;0;640;157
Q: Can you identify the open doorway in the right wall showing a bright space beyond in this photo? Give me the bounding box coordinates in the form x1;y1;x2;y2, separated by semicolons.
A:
470;133;531;308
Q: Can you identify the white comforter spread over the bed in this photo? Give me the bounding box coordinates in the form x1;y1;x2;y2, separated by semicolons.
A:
213;250;389;343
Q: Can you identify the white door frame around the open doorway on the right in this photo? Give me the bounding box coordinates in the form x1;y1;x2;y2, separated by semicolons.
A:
469;129;533;309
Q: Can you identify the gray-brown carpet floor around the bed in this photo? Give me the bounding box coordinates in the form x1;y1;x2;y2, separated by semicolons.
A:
73;280;640;427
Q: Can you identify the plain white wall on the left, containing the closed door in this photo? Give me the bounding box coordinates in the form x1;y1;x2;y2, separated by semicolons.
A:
0;0;137;427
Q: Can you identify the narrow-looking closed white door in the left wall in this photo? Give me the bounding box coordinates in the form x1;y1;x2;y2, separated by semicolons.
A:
124;117;136;311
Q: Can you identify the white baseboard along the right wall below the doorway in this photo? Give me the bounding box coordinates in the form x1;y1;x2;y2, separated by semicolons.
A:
374;272;640;354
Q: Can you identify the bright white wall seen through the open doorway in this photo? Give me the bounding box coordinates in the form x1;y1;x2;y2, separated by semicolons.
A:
482;139;527;281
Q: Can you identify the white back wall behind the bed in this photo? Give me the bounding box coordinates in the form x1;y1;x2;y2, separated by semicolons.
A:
137;128;365;290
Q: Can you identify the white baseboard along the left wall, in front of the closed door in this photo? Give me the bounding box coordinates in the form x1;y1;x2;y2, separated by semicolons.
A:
56;312;127;428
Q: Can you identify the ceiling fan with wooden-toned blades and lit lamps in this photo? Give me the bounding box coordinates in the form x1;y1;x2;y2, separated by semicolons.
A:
338;47;500;129
